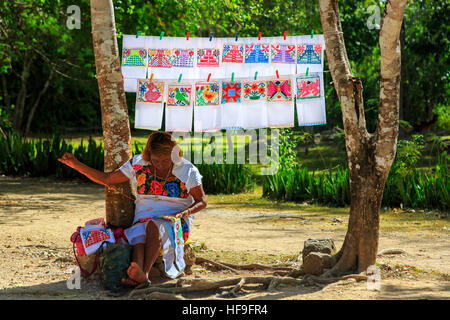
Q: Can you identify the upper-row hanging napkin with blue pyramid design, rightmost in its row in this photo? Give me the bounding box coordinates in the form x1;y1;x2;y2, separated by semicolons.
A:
297;34;325;74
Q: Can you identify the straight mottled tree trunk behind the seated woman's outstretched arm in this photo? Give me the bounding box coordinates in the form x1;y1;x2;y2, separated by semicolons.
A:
91;0;134;227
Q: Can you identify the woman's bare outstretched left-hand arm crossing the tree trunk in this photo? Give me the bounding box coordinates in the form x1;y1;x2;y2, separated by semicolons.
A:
58;153;128;185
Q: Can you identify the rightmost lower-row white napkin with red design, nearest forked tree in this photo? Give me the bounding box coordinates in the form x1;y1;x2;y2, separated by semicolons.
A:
296;72;327;126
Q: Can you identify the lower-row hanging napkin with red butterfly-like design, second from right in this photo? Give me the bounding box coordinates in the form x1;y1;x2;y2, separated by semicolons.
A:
266;77;295;128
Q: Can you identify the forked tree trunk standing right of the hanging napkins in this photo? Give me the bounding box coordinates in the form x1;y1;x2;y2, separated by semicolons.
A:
319;0;406;276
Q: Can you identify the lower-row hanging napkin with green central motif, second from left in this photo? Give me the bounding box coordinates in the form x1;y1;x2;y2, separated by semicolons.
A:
165;82;194;132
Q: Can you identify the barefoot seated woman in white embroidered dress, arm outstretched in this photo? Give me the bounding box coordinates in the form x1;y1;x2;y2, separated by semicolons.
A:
58;131;207;286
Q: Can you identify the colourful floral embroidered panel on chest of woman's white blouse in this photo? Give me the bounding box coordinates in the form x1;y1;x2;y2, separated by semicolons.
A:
133;165;190;198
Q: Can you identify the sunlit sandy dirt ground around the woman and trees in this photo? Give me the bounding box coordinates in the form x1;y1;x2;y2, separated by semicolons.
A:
0;176;450;300
